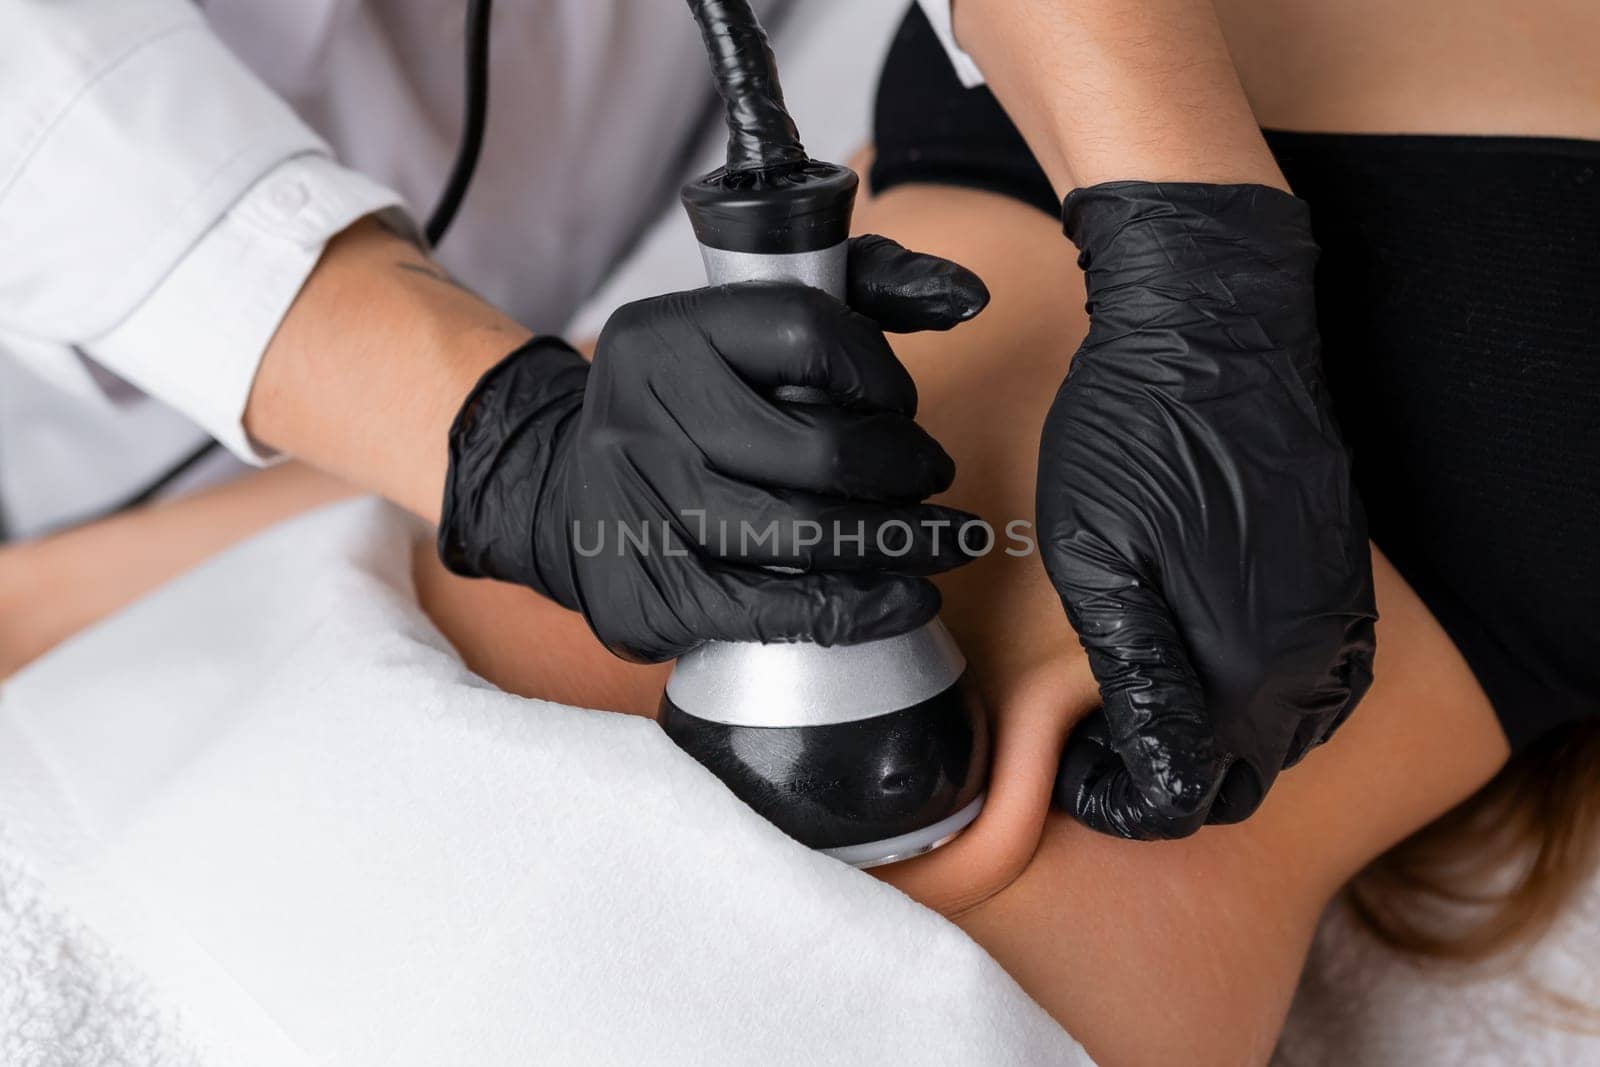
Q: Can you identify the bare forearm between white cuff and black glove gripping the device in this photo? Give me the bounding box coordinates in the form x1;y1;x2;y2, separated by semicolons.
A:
245;221;530;522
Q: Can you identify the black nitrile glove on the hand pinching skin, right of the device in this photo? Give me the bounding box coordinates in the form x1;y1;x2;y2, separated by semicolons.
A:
1037;181;1378;838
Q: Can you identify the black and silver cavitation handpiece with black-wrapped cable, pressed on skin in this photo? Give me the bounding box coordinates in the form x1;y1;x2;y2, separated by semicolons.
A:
661;0;989;867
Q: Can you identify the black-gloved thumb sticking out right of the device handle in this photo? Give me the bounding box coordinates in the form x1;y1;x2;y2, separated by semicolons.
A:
848;234;989;333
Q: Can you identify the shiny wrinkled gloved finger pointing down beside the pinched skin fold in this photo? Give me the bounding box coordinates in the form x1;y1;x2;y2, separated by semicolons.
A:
1058;569;1226;821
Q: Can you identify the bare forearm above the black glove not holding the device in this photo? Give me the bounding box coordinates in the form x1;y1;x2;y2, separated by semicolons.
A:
954;0;1288;195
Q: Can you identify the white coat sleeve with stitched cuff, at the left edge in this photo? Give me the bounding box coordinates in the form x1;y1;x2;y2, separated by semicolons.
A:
0;0;400;462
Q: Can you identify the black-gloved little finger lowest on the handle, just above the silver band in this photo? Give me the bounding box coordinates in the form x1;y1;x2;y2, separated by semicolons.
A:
696;566;939;646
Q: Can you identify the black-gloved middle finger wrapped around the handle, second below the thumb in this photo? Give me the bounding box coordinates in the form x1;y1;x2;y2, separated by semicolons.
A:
690;398;955;502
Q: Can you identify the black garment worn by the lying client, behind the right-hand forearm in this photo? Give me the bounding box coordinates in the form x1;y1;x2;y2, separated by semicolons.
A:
872;6;1600;750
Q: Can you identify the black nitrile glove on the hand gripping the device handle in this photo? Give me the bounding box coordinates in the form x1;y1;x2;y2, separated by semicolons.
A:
438;237;989;662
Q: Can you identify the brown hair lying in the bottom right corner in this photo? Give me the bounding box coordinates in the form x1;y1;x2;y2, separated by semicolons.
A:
1349;721;1600;961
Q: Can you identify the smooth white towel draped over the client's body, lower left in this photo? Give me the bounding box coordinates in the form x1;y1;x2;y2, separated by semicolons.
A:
0;501;1086;1067
